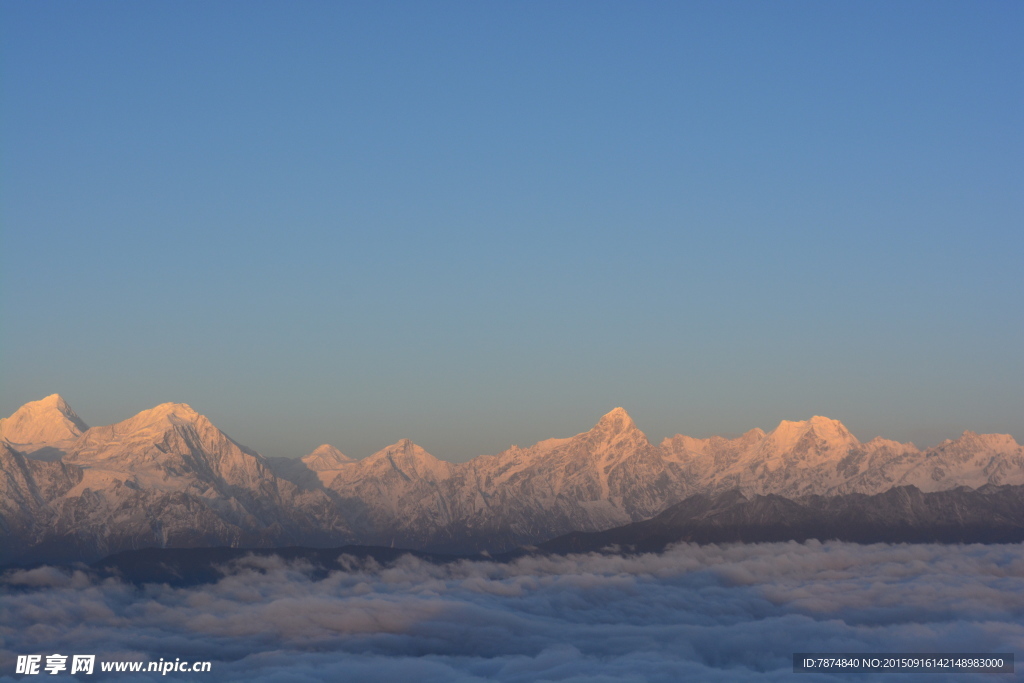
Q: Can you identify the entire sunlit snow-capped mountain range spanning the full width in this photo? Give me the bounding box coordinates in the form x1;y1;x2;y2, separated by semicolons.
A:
0;394;1024;561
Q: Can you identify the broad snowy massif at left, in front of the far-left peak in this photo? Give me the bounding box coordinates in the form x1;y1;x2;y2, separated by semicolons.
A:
0;403;347;558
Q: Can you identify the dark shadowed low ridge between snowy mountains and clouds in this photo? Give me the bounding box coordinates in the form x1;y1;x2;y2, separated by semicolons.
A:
49;485;1024;586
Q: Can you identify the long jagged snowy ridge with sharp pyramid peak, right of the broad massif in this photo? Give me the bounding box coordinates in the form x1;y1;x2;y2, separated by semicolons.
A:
319;409;1024;552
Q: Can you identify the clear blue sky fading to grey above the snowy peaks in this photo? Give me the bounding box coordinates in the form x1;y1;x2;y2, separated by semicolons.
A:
0;0;1024;461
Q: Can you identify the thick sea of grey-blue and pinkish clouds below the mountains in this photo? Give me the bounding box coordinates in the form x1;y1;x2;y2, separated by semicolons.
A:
0;542;1024;683
